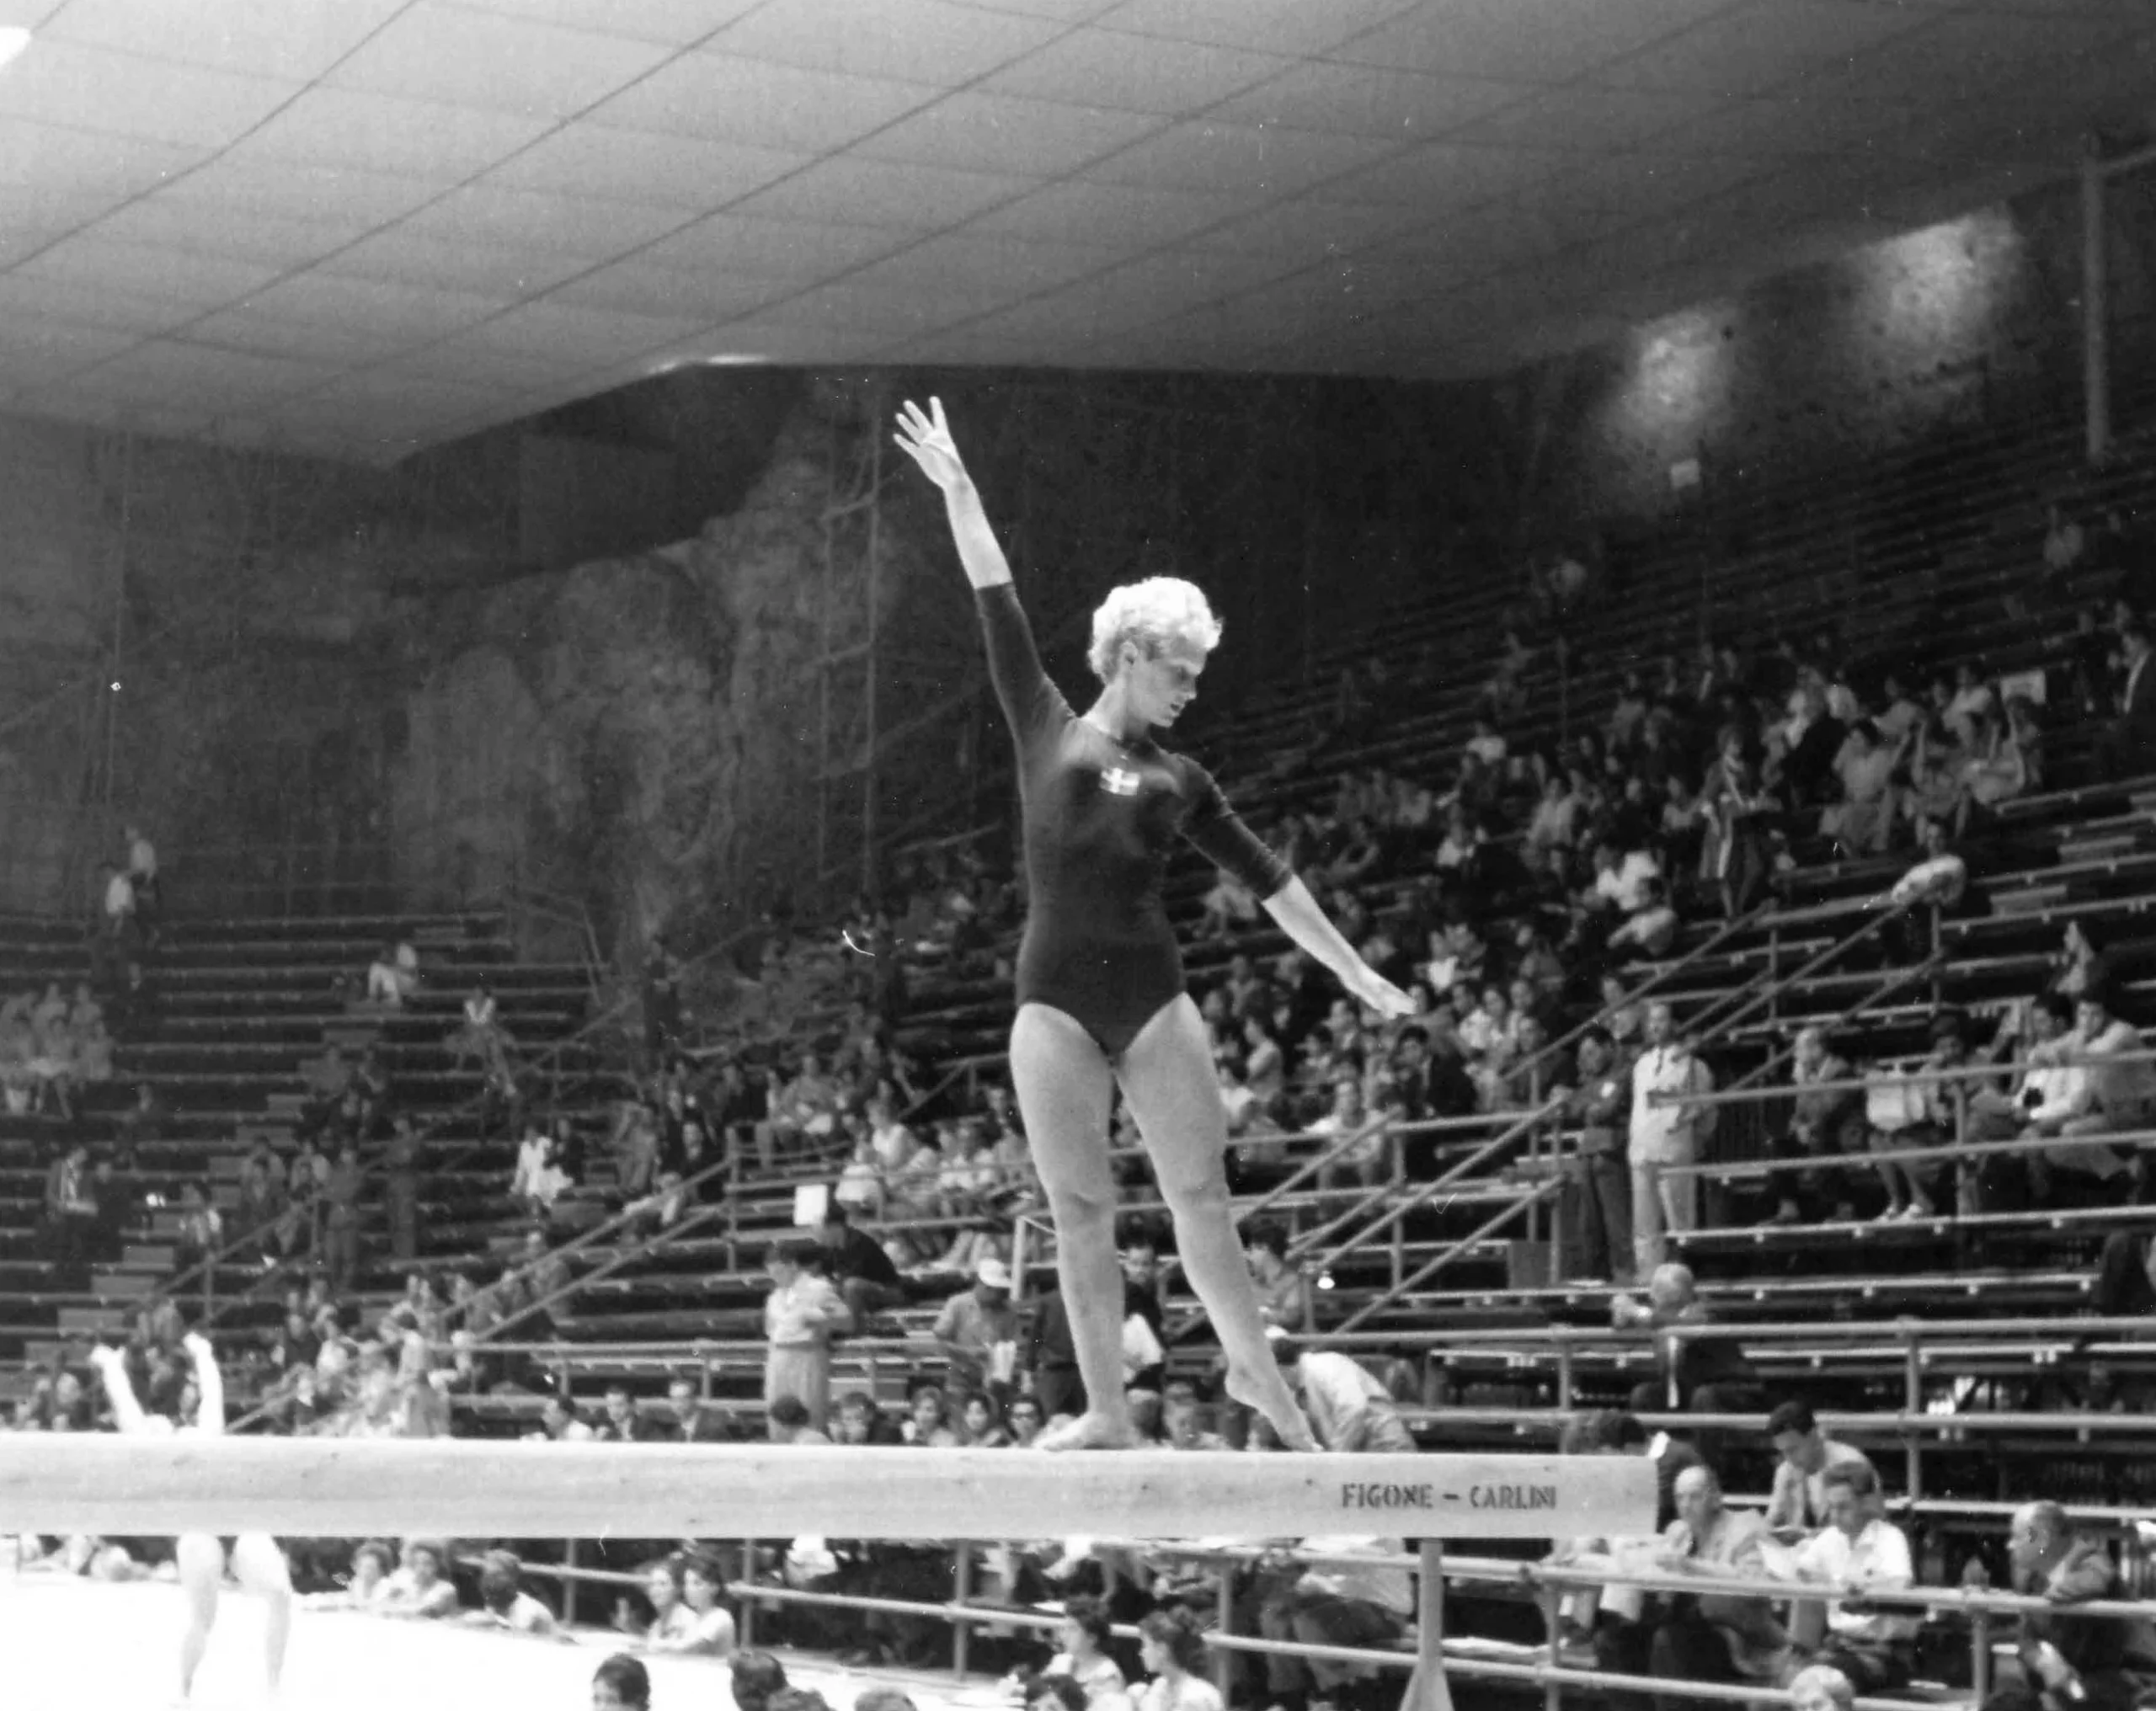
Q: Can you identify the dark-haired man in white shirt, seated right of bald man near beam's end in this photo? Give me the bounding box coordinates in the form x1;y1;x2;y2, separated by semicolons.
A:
1791;1461;1921;1694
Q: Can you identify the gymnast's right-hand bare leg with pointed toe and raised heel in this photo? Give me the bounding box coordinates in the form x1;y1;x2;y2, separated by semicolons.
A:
1117;994;1317;1450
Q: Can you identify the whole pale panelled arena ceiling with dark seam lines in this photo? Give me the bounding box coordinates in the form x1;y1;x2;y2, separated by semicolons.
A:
0;0;2156;461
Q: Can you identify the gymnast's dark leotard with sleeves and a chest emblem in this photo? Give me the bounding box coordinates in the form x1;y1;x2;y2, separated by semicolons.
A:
979;582;1291;1058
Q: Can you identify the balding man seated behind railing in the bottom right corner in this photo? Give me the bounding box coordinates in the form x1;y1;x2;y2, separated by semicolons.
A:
1982;1502;2156;1711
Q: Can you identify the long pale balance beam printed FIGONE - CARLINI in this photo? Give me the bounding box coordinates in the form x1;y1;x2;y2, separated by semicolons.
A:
0;1433;1656;1538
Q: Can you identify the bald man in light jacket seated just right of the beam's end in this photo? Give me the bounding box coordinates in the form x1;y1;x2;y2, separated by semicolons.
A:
1649;1465;1790;1711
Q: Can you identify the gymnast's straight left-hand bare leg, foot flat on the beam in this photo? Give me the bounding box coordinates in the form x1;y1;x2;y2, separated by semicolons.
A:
1011;1005;1138;1450
